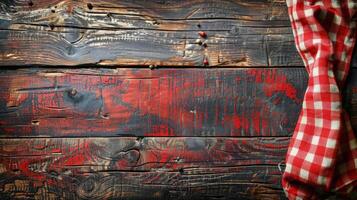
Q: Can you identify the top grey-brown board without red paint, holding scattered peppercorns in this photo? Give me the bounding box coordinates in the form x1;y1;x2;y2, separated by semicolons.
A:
0;0;302;67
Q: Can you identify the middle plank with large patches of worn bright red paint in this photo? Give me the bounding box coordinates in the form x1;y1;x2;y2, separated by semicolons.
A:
0;68;307;137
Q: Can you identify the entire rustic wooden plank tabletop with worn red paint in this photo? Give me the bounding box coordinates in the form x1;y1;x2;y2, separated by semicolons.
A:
0;0;357;200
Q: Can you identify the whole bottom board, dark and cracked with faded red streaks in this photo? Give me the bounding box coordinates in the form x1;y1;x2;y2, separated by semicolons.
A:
0;137;289;199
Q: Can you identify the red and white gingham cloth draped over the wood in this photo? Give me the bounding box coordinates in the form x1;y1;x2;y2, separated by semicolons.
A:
282;0;357;199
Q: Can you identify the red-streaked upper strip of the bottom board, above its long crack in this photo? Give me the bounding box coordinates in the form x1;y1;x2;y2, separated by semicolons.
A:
0;137;289;170
